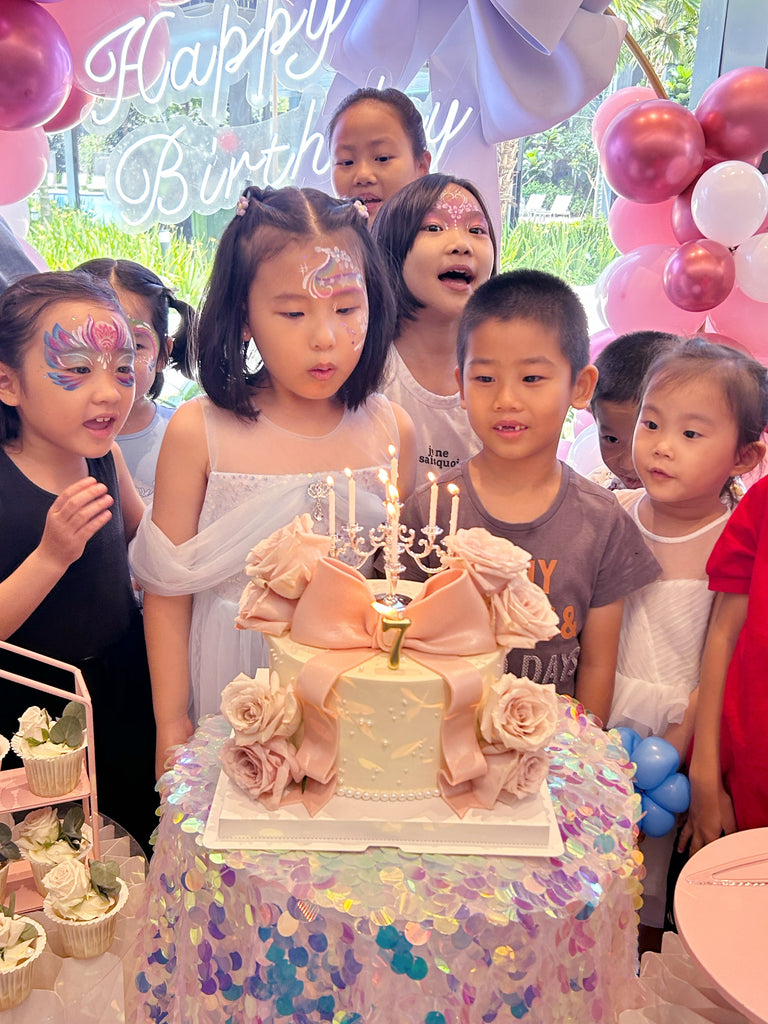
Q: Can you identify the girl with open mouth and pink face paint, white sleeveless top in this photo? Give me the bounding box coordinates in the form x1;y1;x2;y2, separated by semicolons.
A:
374;174;497;472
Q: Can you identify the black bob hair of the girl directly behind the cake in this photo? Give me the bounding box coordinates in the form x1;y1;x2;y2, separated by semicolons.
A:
195;185;394;420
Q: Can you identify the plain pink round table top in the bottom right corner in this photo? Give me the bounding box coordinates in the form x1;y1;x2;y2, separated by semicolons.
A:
675;828;768;1024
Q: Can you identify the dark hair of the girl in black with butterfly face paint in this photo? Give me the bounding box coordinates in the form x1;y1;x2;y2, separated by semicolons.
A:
0;270;125;444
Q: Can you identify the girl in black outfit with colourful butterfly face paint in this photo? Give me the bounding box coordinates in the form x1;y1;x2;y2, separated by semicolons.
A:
0;271;156;844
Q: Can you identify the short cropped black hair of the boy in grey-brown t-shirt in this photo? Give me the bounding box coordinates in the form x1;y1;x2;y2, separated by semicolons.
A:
456;268;590;381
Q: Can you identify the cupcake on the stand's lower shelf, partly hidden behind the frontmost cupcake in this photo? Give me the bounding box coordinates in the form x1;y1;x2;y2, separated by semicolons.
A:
16;806;93;896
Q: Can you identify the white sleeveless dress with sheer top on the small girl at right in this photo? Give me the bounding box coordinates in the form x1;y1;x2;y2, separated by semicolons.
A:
608;489;730;736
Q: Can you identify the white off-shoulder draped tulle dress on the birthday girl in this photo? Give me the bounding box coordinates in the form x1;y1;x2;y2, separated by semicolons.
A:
129;395;399;724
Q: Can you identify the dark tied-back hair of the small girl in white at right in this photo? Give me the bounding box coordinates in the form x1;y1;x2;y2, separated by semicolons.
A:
643;337;768;450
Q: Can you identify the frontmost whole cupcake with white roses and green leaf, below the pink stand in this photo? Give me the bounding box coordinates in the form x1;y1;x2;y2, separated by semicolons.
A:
43;860;128;959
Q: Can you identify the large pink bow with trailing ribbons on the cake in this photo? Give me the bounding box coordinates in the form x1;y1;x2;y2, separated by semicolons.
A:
291;558;497;815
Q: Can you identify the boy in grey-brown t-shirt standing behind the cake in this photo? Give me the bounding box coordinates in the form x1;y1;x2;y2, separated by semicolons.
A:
401;270;659;722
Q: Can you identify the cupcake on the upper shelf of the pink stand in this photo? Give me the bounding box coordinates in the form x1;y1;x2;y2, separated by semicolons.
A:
11;700;85;797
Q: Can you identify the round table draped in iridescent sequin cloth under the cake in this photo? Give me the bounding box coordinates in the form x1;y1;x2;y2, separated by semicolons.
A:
126;697;642;1024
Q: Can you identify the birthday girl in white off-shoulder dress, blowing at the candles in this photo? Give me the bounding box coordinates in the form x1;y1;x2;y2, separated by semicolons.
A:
132;187;414;769
